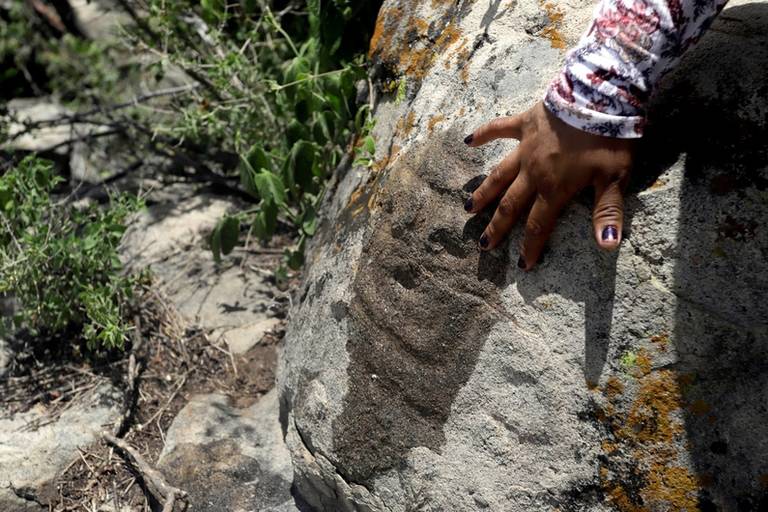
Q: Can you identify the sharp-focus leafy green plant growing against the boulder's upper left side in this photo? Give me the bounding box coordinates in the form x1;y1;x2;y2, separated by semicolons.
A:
126;0;378;268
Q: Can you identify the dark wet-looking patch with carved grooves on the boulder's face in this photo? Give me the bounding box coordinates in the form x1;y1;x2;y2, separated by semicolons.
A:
333;133;509;482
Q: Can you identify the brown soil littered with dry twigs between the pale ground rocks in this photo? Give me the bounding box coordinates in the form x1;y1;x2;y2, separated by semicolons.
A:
0;274;294;511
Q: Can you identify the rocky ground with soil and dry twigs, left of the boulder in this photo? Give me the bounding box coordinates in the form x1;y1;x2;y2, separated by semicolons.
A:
0;171;295;512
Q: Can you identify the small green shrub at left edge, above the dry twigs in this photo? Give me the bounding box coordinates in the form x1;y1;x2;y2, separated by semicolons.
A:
0;157;140;349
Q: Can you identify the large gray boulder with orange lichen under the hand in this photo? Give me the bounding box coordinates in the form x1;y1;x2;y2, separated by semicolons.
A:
278;0;768;511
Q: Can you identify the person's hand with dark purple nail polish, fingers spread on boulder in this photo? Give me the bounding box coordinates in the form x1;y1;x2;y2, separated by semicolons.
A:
464;102;634;270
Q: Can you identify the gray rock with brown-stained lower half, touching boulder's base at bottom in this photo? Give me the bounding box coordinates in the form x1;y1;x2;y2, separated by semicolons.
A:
159;389;298;512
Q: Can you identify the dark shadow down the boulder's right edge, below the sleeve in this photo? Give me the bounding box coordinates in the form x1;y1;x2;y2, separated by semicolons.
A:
644;4;768;511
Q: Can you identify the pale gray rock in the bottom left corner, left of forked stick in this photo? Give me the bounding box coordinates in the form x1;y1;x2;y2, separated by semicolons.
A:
0;384;122;512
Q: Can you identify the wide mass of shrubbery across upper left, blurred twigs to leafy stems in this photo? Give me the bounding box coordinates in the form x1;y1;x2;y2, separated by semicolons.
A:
0;0;381;275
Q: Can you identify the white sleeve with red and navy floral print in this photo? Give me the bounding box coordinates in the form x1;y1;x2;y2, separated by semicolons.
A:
544;0;728;138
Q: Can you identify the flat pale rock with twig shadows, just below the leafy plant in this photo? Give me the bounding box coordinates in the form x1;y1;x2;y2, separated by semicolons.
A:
122;185;280;354
